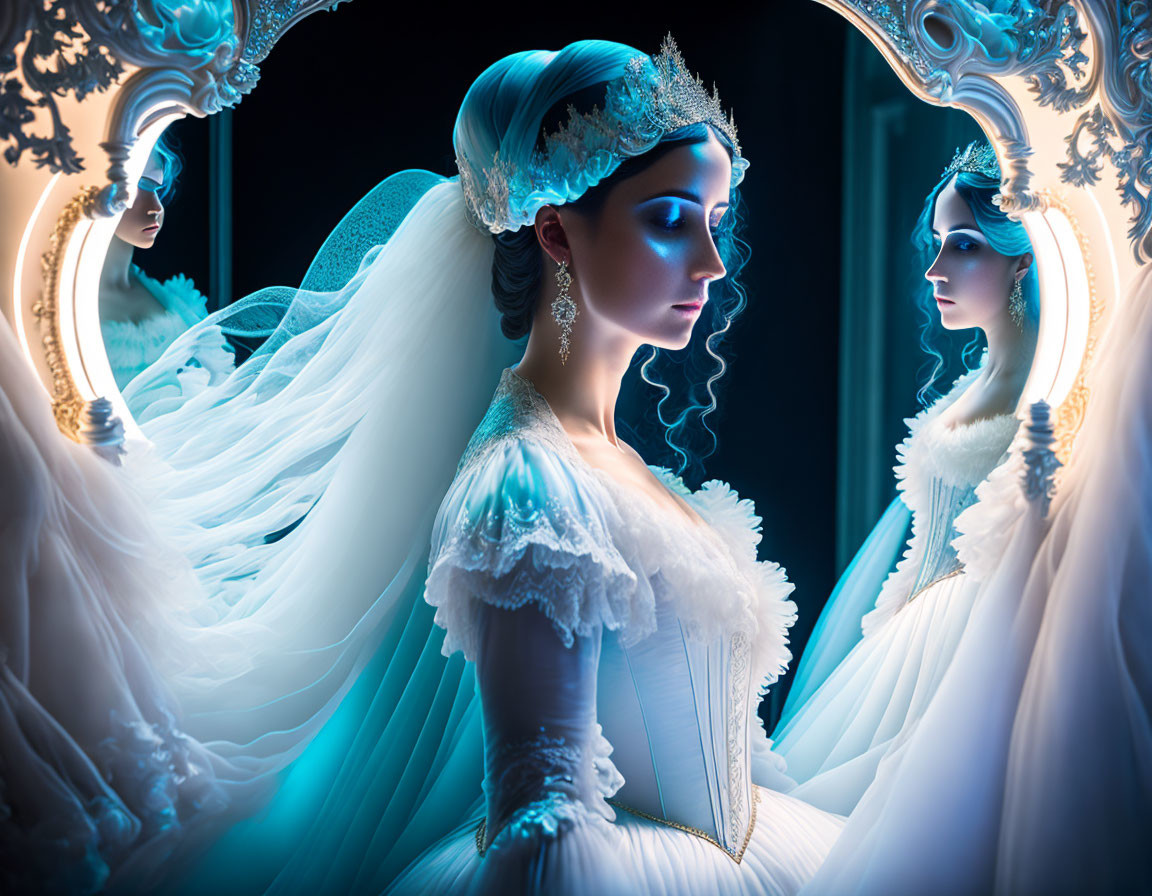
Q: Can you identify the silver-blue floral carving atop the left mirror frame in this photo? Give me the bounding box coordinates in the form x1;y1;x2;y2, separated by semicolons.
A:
0;0;341;202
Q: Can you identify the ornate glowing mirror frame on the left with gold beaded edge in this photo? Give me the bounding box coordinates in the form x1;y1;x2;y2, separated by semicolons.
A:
0;0;343;447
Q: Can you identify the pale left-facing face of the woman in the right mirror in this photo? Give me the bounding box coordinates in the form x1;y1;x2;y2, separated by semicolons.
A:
924;177;1018;329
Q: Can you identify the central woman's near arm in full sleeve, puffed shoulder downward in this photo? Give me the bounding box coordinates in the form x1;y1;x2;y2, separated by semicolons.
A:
426;440;638;894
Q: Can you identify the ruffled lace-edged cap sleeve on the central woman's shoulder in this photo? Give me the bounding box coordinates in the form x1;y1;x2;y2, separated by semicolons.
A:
425;436;654;660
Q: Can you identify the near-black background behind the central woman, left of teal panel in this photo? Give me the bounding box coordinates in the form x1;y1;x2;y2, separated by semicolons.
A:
146;0;847;714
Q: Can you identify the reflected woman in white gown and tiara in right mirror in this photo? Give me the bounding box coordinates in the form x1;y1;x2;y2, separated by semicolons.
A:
775;143;1039;814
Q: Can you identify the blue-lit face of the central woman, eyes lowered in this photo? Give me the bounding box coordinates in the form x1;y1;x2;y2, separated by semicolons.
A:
563;134;732;349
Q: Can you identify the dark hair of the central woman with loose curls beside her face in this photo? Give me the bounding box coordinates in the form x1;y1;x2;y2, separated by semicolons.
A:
492;84;749;478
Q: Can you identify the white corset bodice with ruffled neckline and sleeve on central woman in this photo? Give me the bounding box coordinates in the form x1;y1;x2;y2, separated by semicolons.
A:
426;371;795;858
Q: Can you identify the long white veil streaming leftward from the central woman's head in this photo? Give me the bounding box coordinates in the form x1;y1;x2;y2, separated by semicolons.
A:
126;172;517;774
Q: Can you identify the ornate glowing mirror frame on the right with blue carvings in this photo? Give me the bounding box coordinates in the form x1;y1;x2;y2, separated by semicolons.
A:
817;0;1152;481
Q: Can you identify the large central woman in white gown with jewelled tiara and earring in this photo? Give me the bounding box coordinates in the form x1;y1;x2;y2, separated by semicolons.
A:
148;34;842;894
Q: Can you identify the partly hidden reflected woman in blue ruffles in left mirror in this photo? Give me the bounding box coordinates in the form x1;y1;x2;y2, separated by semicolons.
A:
100;137;234;415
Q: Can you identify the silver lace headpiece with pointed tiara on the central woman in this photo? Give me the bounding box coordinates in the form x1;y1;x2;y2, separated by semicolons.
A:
456;35;748;234
